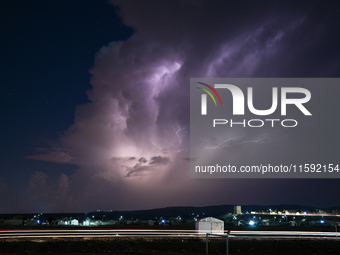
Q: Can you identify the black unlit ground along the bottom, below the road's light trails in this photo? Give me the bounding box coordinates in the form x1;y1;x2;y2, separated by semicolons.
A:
0;237;340;255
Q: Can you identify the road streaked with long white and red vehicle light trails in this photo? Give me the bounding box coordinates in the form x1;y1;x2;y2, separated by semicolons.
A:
0;229;338;239
